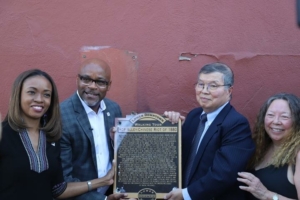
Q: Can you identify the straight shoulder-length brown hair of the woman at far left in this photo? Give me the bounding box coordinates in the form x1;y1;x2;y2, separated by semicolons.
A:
5;69;62;142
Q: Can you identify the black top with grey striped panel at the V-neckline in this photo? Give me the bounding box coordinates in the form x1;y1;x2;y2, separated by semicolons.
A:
0;122;67;200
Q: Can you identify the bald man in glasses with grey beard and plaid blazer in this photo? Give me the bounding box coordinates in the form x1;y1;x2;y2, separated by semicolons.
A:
60;59;124;200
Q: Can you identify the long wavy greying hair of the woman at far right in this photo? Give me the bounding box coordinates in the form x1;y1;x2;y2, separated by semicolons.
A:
249;93;300;169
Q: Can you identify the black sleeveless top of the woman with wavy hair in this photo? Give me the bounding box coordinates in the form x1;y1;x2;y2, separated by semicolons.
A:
248;164;298;200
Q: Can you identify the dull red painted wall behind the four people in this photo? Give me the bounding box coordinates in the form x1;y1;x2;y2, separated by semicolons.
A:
0;0;300;126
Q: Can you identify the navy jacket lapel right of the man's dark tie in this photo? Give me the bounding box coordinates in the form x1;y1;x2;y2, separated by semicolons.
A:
190;103;231;181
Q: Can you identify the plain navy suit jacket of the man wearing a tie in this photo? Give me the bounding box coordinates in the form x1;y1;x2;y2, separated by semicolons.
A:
182;103;255;200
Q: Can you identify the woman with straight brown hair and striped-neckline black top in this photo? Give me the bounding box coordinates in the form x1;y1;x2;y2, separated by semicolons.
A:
0;69;126;200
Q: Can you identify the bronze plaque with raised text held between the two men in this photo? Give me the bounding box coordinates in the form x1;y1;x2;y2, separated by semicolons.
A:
114;113;181;200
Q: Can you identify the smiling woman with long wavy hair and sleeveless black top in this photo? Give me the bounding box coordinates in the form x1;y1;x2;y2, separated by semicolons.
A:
238;93;300;200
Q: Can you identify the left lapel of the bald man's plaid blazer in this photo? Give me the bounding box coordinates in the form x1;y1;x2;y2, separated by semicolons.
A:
72;93;97;169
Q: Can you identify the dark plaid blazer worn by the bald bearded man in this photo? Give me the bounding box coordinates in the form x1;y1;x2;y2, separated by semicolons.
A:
60;93;122;200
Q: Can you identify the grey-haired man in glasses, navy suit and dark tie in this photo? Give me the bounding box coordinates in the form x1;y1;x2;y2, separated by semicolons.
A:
164;63;254;200
